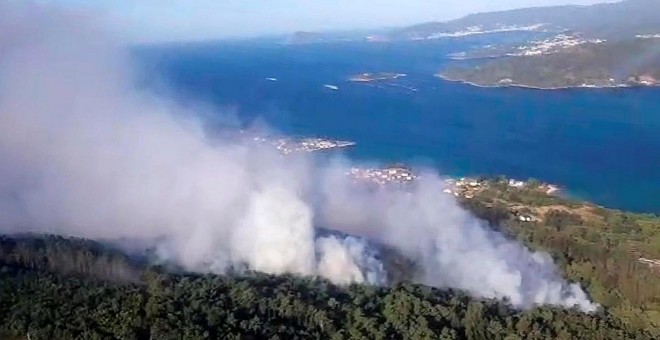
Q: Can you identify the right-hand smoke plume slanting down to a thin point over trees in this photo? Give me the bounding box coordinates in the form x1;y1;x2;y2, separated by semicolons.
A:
323;174;596;310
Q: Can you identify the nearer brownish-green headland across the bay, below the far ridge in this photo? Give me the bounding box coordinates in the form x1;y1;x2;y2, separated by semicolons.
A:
442;39;660;89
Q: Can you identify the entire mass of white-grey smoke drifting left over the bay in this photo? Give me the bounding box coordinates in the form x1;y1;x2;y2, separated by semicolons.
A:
0;1;595;311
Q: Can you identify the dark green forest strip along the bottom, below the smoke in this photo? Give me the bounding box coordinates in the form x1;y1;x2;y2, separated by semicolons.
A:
0;238;651;339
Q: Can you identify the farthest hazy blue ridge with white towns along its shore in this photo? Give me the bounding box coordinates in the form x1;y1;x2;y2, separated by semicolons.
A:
286;0;660;44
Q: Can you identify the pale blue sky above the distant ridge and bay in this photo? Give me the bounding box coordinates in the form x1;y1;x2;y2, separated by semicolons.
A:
47;0;603;41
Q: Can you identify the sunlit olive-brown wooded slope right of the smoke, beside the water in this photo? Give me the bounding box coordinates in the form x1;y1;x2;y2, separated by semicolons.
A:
464;181;660;334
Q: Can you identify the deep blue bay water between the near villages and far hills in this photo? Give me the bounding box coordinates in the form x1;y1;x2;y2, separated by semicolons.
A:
142;38;660;213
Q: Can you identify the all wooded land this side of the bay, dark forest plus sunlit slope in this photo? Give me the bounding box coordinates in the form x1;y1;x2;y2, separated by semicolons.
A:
0;182;660;340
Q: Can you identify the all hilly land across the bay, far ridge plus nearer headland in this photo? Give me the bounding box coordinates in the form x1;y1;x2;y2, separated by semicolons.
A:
282;0;660;89
